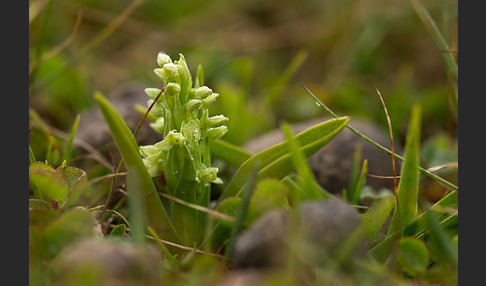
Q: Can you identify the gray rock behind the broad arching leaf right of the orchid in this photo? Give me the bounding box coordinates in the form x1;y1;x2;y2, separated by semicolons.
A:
243;118;402;194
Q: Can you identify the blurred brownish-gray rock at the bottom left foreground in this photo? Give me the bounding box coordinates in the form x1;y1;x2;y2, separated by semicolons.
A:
55;239;162;286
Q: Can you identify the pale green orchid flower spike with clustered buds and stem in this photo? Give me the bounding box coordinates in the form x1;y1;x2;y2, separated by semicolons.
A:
140;52;228;243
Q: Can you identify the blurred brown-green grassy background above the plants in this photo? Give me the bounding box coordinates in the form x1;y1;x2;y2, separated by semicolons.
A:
29;0;458;194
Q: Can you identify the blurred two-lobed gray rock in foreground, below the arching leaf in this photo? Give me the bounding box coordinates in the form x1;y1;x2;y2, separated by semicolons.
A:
233;199;365;268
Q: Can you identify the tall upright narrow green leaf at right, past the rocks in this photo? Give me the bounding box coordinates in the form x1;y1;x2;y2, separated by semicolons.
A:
388;105;421;234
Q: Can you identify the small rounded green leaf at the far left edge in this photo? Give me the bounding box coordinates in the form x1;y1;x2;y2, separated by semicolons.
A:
29;162;68;202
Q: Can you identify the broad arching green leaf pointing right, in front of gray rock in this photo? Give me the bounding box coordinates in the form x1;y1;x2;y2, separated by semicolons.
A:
219;117;349;202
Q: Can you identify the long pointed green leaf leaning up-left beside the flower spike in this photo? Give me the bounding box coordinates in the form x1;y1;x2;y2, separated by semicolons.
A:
94;93;179;244
